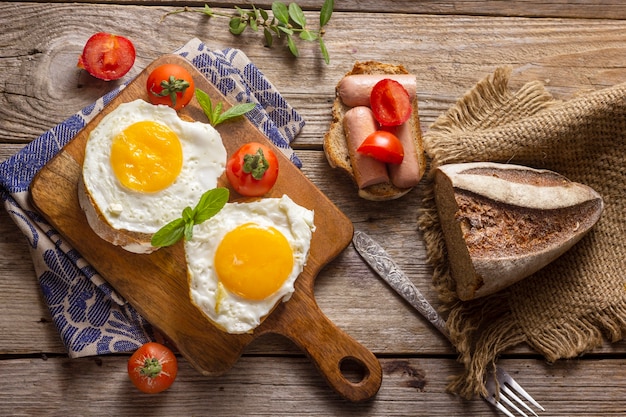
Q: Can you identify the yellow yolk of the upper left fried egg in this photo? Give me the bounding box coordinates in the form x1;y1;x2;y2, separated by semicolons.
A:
110;121;183;193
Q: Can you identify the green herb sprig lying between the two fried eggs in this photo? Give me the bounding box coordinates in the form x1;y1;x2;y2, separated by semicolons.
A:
150;187;230;247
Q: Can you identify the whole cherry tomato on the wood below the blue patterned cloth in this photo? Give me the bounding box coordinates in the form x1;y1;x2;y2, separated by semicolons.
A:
128;342;178;394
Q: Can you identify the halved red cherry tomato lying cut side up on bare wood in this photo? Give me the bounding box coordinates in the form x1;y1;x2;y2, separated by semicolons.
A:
78;32;135;81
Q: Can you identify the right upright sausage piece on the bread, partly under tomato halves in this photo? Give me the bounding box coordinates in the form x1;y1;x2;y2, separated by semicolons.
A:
384;120;420;188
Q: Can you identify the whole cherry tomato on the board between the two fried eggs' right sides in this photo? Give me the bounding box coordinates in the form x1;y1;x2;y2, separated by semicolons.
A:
226;142;278;197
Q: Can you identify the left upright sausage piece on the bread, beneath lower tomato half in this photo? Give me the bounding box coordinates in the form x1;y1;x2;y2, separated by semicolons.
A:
343;106;389;188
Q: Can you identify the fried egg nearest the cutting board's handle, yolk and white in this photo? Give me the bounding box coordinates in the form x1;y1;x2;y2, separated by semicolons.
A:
184;195;315;334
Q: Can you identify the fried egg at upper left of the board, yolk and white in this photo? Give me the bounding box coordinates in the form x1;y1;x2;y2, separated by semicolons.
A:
83;100;227;252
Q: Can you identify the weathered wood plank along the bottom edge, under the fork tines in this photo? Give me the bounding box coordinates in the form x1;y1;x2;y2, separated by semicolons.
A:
0;356;626;417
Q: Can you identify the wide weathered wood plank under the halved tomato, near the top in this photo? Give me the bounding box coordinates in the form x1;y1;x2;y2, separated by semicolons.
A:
0;2;626;148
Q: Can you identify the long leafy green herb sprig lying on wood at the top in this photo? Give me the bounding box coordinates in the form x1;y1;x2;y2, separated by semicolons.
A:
161;0;335;64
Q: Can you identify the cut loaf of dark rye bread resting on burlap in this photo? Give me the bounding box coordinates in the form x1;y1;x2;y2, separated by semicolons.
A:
434;162;604;300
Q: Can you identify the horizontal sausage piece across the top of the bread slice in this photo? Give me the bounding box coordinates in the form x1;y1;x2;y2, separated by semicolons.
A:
337;74;417;107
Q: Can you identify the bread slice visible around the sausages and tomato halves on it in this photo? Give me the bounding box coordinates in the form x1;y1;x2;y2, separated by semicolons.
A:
324;61;426;201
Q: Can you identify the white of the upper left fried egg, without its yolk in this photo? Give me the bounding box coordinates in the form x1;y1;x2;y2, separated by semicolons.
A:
83;100;227;234
